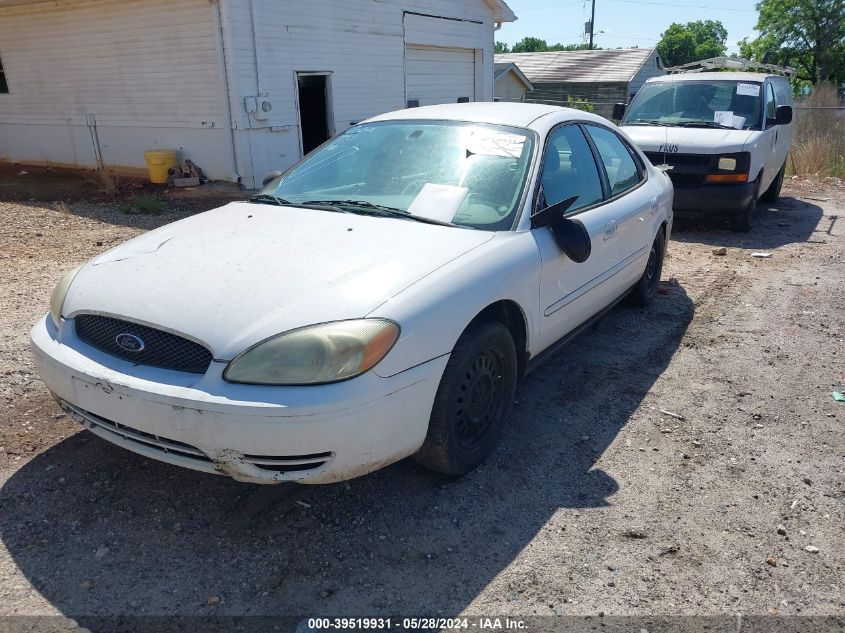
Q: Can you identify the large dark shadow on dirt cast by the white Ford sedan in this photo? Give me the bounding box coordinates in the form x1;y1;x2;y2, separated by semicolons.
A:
0;284;693;625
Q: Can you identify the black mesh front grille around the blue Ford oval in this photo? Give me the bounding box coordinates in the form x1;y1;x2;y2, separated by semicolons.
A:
74;314;212;374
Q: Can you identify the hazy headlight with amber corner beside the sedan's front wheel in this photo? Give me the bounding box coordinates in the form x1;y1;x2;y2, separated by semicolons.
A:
223;319;399;385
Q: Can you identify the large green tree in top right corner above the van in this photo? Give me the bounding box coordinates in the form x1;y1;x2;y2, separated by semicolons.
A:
740;0;845;85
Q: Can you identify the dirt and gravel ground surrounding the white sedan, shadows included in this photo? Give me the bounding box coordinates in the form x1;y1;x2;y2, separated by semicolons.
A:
0;173;845;630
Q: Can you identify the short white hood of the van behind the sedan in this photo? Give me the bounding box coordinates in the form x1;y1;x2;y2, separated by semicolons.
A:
622;125;758;154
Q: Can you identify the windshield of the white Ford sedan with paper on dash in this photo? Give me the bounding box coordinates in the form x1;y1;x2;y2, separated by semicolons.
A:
256;121;534;231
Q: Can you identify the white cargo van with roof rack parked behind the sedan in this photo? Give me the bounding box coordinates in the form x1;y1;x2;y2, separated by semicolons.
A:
613;72;792;231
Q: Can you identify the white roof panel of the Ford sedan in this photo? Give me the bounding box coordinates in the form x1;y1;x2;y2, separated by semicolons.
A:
364;101;572;127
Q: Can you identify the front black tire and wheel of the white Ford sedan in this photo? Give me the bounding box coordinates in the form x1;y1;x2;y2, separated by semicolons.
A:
414;321;517;475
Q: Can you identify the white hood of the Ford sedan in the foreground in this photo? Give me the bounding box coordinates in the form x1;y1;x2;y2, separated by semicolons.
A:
63;202;494;360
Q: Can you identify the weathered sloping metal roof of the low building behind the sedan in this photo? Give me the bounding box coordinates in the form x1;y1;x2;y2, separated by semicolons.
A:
495;48;657;84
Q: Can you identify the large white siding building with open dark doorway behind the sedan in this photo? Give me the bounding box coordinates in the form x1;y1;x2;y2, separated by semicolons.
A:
0;0;515;187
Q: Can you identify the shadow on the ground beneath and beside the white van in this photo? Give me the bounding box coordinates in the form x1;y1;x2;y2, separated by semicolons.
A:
672;197;824;250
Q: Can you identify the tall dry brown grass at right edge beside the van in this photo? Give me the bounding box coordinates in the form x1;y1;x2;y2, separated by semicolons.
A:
787;85;845;178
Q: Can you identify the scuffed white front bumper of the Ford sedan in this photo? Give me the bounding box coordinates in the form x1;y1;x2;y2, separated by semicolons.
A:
31;316;448;483
